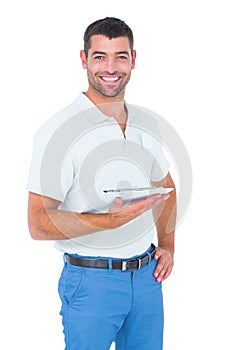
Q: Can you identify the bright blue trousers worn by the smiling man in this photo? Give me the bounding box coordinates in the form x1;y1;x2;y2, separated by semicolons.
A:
58;247;164;350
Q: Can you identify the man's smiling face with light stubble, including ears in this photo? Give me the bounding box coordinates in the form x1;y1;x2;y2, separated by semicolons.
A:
80;35;136;97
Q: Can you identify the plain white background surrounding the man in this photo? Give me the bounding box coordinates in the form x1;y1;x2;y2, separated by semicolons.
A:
0;0;233;350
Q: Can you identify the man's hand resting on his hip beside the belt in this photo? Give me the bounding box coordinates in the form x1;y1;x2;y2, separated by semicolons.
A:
154;247;174;282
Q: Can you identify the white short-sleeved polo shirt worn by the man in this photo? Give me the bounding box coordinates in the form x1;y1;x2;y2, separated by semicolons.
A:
27;93;169;258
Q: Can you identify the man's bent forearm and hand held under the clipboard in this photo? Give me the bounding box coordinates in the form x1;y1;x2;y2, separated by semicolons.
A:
28;192;167;240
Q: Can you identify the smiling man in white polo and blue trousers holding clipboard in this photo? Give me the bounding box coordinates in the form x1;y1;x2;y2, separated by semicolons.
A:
27;18;176;350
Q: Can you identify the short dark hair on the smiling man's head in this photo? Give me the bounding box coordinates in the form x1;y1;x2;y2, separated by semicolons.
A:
83;17;134;56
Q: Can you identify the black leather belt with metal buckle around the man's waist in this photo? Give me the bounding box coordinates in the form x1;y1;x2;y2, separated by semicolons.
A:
64;244;156;271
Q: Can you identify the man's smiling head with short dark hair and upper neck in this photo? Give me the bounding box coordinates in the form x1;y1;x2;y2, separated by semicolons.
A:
80;17;136;100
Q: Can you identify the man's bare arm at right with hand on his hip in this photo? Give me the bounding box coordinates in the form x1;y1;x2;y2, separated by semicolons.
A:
152;173;176;282
